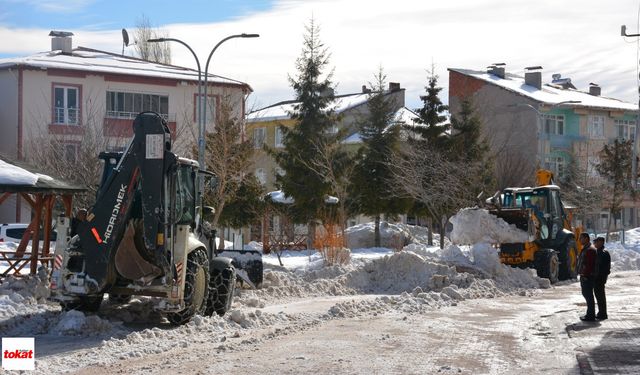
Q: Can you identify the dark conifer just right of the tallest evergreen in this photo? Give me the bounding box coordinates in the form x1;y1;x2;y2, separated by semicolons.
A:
351;69;406;246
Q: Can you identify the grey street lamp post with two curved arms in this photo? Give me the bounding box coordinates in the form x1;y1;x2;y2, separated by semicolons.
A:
147;33;260;229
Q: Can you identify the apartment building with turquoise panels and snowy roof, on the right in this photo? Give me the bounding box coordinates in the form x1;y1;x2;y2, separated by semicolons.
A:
448;64;640;231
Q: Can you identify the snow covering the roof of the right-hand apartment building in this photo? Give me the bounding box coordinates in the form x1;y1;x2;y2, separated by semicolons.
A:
449;68;638;111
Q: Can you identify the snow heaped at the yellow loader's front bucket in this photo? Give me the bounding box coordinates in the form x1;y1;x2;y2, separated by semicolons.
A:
449;208;529;245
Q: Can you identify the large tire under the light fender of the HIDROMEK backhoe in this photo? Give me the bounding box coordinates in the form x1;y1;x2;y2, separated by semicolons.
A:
167;249;209;325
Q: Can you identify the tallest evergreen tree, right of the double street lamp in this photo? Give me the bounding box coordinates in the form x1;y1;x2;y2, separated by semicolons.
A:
270;19;336;226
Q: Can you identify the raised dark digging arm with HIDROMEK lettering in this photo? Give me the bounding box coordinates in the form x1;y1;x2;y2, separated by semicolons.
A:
68;112;177;294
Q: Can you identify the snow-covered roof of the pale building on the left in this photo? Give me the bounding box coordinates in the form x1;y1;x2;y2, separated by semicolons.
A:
0;47;250;88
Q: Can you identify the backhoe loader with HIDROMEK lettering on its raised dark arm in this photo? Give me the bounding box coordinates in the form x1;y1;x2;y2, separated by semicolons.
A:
51;112;236;324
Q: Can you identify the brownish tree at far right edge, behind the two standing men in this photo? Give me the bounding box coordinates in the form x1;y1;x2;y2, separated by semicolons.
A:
595;139;636;241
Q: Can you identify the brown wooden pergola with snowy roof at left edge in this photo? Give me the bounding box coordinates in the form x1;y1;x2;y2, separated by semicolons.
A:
0;159;86;277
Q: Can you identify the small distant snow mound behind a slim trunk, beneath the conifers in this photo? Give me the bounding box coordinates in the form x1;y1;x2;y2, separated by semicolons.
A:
344;221;412;249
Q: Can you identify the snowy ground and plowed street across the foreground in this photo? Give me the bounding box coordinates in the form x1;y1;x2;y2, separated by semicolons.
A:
0;219;640;374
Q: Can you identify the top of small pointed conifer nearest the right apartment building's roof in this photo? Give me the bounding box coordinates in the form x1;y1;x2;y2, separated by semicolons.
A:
408;66;449;147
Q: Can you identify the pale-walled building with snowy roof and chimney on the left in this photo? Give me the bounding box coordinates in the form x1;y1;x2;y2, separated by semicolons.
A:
0;32;252;222
